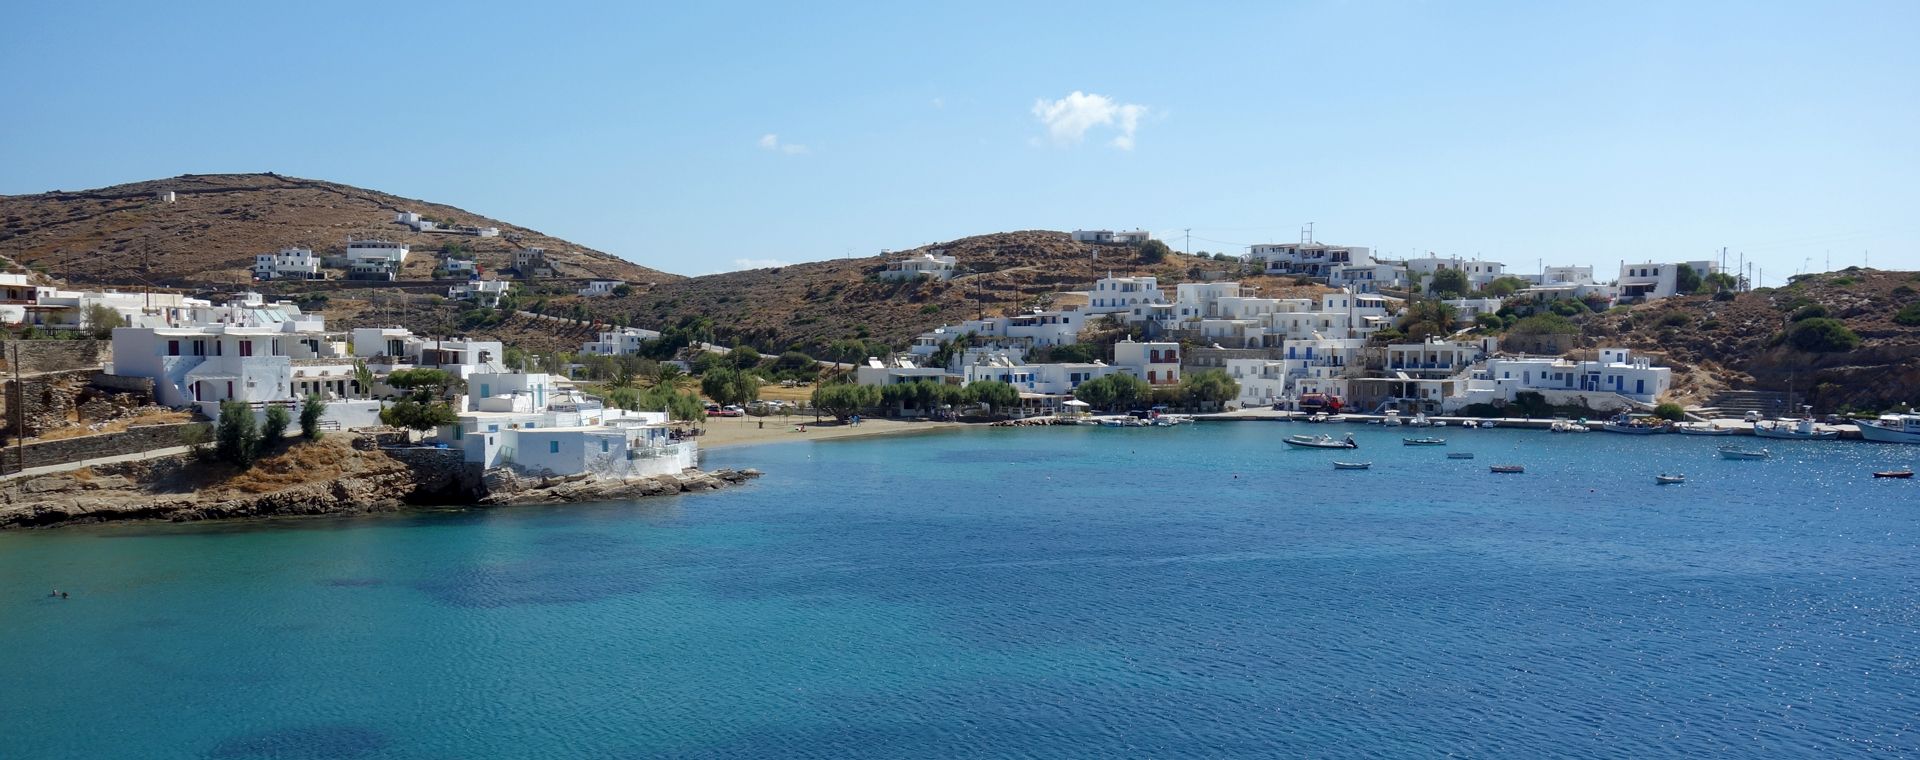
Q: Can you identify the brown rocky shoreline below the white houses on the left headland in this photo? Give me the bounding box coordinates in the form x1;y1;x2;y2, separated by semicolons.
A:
0;433;760;530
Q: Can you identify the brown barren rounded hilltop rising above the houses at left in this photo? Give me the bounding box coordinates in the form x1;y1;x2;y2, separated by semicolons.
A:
0;173;680;288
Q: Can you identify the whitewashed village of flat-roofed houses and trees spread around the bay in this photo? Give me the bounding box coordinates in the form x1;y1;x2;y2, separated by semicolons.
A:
0;198;1920;525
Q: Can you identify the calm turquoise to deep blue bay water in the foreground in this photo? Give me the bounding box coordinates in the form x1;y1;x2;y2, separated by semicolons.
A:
0;422;1920;758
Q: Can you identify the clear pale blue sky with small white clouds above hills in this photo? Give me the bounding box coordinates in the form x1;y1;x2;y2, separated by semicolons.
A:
0;2;1920;280
